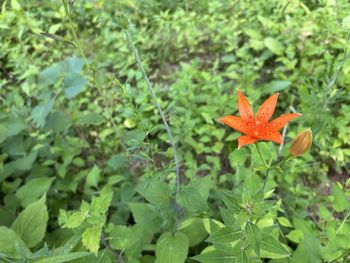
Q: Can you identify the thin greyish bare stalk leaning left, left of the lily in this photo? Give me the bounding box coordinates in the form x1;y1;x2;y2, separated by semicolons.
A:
124;29;180;194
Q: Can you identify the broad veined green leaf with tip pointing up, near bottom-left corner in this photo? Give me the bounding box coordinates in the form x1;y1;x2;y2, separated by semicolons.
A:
11;196;49;248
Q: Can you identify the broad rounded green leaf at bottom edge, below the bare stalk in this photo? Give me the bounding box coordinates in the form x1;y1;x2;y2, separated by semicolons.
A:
156;232;189;263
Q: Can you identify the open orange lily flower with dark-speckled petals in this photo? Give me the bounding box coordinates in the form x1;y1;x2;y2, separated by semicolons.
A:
219;90;301;149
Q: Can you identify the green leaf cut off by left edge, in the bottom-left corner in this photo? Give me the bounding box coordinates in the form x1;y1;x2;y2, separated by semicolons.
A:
0;226;29;258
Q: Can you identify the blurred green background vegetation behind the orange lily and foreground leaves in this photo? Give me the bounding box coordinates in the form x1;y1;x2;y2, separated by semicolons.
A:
0;0;350;262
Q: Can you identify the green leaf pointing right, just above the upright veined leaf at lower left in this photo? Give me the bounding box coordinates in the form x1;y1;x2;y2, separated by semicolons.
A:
16;177;54;207
